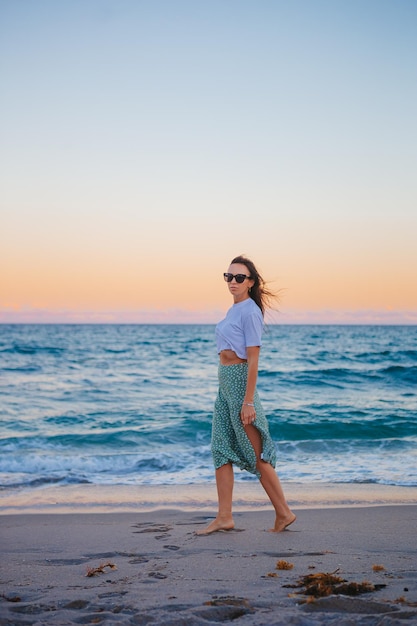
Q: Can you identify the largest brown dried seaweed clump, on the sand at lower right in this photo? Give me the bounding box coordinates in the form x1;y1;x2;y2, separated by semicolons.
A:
285;570;385;598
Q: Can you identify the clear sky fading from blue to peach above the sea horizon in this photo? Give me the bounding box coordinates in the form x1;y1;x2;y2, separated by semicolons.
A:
0;0;417;324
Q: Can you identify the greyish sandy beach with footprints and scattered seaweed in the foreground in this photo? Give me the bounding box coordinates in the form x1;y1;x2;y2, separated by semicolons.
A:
0;490;417;626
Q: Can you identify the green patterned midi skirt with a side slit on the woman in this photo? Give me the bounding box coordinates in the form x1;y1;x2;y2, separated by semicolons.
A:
211;363;276;477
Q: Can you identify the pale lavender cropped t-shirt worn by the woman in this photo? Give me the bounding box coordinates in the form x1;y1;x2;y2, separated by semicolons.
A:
216;298;264;359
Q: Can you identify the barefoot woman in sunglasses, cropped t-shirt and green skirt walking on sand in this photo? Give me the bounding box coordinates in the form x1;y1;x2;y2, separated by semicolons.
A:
197;256;296;535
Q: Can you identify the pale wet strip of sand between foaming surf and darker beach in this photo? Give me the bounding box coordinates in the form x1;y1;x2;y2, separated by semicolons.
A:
0;481;417;516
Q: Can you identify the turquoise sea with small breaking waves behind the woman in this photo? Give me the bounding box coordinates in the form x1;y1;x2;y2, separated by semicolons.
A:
0;325;417;490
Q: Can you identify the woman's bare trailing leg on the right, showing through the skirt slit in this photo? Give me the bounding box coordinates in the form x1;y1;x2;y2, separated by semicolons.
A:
245;425;296;533
